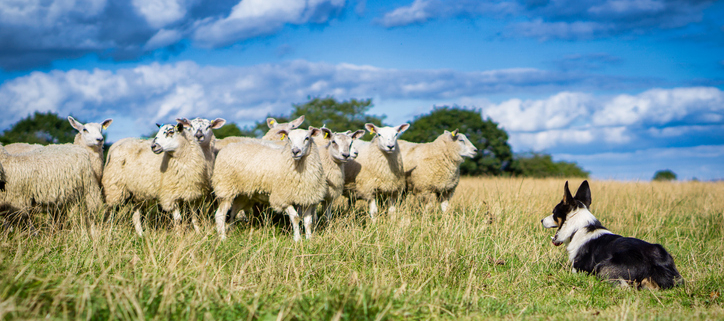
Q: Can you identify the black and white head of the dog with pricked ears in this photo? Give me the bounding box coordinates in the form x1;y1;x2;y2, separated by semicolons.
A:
541;181;591;246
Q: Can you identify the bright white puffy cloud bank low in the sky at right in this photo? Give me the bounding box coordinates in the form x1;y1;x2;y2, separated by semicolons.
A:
479;87;724;151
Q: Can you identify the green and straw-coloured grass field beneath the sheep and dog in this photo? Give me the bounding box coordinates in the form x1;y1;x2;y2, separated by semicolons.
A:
0;178;724;320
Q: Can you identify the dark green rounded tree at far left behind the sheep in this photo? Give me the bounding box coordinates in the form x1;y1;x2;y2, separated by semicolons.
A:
0;111;78;145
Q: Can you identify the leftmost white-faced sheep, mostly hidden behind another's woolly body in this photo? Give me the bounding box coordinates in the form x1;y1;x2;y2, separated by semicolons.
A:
5;116;113;184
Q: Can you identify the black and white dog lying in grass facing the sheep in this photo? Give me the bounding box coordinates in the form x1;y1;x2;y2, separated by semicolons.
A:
541;181;682;289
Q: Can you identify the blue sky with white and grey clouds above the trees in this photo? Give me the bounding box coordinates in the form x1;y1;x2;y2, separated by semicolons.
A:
0;0;724;180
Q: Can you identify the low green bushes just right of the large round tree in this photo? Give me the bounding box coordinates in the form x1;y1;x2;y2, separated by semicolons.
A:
513;153;590;178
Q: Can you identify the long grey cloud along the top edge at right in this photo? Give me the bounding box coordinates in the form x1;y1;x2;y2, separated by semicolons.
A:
381;0;714;40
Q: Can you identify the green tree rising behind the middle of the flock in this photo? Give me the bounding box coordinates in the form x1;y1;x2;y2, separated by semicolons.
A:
242;96;386;137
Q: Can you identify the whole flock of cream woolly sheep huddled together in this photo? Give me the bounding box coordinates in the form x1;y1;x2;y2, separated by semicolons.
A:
0;116;477;241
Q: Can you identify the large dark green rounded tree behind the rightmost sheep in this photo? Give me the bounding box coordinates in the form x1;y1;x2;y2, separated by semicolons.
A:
402;106;513;175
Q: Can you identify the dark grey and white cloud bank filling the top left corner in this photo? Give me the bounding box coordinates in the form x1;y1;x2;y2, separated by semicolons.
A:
0;0;345;70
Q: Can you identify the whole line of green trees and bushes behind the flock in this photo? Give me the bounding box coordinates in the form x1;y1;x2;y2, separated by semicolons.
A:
0;97;589;178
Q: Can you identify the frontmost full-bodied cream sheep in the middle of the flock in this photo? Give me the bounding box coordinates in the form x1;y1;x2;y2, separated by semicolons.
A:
211;127;327;241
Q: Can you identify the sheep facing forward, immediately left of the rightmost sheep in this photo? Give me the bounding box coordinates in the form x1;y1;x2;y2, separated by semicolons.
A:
344;123;410;220
